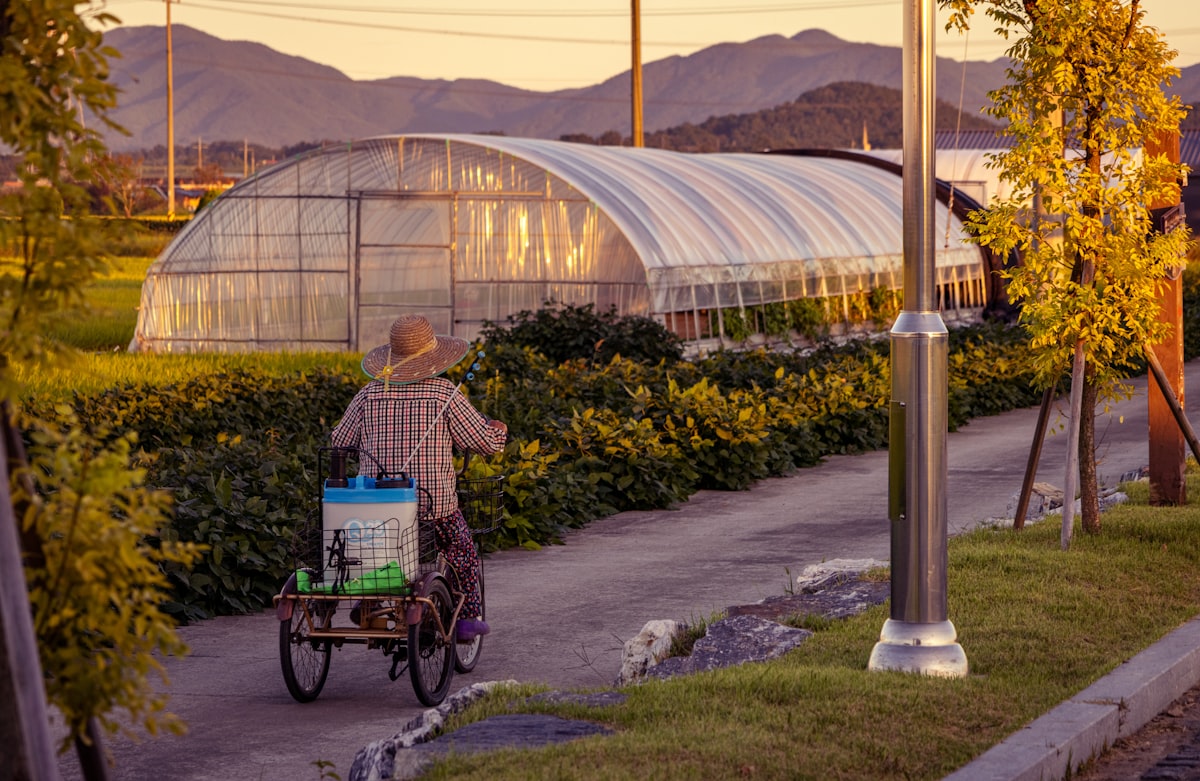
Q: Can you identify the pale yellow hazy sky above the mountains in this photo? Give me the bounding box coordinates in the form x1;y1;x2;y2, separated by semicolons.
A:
94;0;1200;91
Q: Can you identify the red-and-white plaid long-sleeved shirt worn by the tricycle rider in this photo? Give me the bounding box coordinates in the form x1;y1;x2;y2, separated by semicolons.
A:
330;377;506;518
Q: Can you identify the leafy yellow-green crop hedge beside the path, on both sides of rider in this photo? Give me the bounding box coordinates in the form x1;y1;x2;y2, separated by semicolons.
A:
25;316;1038;620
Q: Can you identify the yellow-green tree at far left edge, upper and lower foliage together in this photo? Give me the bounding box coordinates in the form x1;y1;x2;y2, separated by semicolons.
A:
0;0;204;763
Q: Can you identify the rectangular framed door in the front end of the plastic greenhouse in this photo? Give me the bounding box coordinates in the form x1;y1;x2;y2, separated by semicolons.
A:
348;192;458;350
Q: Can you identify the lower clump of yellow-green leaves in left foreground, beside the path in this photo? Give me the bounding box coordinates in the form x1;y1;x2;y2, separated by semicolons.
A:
13;416;198;750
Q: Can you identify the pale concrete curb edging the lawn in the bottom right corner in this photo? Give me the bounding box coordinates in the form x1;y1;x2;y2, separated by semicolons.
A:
943;617;1200;781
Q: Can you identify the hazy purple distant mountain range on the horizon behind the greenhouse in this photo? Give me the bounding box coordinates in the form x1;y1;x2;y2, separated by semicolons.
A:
104;24;1200;151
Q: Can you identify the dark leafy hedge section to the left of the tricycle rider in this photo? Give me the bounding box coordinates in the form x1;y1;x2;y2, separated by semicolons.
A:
29;372;359;620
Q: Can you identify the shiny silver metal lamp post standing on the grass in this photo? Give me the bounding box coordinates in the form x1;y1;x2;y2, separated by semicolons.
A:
868;0;967;678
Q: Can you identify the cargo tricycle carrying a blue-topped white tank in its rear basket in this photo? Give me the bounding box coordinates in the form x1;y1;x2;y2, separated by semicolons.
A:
275;447;504;705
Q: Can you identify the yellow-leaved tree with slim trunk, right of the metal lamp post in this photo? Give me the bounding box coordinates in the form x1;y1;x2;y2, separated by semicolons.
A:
938;0;1188;547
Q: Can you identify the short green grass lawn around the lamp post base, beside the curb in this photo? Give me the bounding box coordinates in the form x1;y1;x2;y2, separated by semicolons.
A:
428;473;1200;780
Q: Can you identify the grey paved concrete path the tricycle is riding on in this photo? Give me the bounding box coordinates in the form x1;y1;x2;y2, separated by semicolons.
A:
51;362;1200;781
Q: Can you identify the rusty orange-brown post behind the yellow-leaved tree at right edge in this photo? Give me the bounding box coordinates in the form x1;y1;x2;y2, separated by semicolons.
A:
1145;132;1187;505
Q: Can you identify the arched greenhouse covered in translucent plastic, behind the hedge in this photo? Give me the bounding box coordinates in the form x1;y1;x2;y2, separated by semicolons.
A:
131;134;985;352
